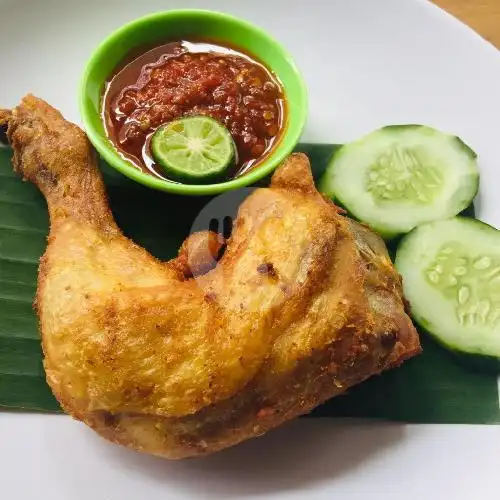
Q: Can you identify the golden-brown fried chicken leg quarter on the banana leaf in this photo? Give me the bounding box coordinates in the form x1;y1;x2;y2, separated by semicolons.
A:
0;96;420;458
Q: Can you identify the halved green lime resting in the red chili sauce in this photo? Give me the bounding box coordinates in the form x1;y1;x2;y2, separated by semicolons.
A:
151;115;236;184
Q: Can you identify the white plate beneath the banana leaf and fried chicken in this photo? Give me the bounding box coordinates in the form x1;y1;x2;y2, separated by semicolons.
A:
0;0;500;500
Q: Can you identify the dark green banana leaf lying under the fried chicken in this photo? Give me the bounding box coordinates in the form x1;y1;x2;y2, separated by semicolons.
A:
0;144;500;424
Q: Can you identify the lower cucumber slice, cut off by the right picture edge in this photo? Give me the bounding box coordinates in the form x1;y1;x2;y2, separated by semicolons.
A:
396;217;500;371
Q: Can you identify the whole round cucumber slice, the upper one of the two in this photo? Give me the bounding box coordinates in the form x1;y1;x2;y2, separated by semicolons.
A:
319;125;479;239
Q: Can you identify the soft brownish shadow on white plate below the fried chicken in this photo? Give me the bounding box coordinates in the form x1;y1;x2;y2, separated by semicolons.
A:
94;419;406;499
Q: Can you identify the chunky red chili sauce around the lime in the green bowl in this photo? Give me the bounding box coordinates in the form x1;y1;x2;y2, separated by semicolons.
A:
102;41;286;179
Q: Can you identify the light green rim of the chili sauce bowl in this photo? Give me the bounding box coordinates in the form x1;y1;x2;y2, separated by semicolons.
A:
79;9;308;195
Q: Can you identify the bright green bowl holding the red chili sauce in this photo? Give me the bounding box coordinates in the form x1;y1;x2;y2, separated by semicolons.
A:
79;10;307;195
